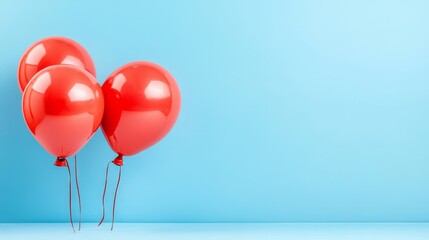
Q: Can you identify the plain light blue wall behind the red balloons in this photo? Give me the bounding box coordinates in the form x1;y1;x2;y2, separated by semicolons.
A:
0;0;429;222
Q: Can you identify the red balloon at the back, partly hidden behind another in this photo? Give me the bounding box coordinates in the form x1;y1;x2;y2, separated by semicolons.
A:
18;37;95;92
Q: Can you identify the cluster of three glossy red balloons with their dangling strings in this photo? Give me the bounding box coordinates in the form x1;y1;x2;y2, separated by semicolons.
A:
18;37;181;230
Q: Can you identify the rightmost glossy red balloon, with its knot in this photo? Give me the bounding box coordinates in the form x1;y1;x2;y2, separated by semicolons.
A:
101;61;181;165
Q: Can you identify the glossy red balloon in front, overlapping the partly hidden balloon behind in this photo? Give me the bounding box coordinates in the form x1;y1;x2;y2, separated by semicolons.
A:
22;65;104;162
